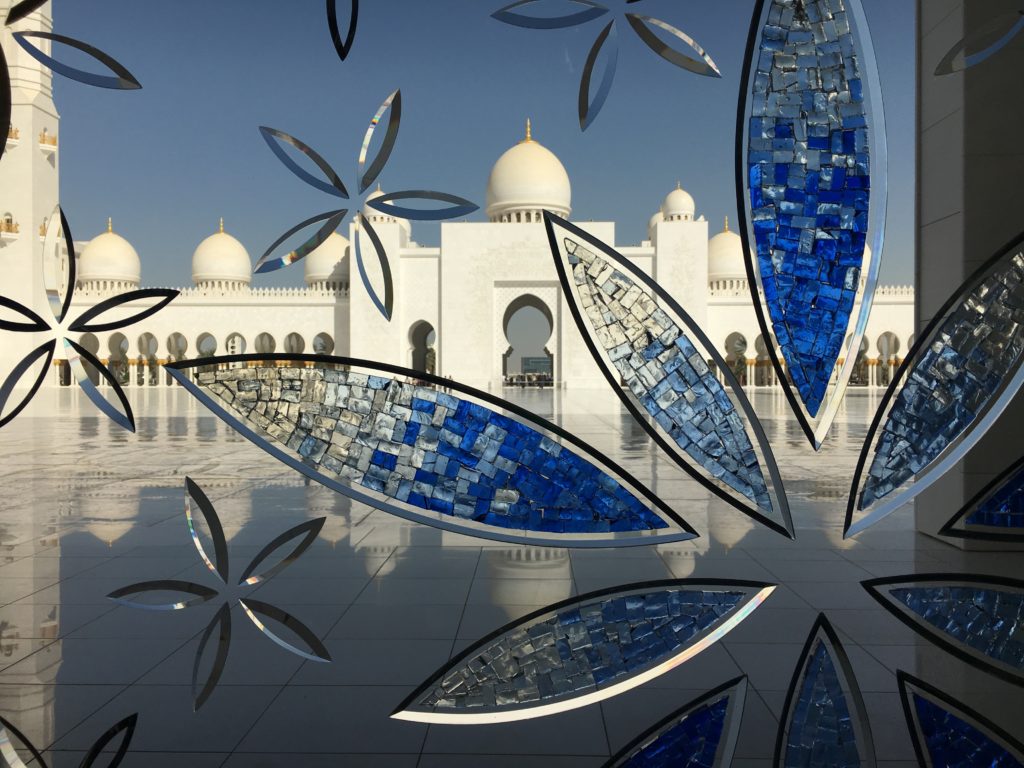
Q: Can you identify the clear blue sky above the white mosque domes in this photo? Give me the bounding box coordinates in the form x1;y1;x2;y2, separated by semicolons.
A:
53;0;914;286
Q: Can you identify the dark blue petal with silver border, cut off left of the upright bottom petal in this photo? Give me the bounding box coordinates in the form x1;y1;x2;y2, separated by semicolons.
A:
605;677;746;768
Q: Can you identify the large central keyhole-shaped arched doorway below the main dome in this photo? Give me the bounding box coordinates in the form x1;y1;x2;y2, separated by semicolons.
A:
502;294;555;386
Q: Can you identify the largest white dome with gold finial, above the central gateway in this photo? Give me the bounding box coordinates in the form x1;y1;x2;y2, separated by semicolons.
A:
487;120;572;222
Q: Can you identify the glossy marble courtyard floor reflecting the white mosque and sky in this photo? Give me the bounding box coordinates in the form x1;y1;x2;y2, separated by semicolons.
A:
0;390;1024;768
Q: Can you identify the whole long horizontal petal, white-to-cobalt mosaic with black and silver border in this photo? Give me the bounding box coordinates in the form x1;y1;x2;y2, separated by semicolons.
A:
167;354;696;546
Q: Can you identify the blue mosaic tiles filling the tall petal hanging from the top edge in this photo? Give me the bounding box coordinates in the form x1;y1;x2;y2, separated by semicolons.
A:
746;0;870;417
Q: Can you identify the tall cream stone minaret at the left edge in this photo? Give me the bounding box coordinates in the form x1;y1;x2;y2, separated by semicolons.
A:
0;0;58;386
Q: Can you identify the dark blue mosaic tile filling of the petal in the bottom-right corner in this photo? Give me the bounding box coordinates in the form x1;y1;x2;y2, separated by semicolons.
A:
911;693;1021;768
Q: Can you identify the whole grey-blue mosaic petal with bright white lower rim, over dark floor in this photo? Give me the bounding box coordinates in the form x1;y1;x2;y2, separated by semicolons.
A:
391;580;775;724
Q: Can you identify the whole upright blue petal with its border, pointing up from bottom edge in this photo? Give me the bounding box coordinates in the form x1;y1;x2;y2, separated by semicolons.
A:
775;614;874;768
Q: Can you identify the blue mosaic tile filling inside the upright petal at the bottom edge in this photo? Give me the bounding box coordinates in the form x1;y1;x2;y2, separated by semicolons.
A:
782;642;861;768
